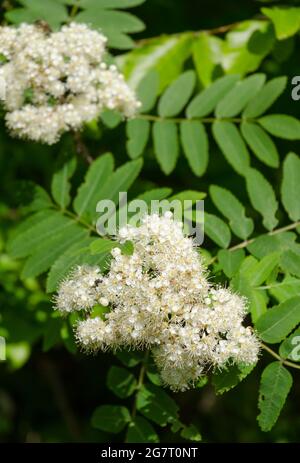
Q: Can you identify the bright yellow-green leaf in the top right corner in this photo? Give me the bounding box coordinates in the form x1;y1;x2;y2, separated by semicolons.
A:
261;7;300;40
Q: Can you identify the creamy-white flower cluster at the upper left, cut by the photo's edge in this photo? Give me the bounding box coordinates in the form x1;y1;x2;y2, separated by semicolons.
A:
0;23;140;144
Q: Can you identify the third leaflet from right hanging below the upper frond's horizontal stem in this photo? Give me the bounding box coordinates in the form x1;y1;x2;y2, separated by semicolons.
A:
212;121;250;175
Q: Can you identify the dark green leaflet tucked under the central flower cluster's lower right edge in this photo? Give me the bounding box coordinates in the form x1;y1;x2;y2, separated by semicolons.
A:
212;365;255;395
